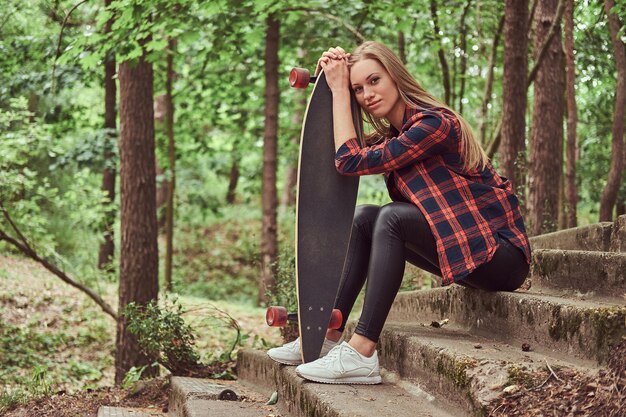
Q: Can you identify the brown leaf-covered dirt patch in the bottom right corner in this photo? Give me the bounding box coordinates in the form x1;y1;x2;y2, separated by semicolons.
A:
487;341;626;417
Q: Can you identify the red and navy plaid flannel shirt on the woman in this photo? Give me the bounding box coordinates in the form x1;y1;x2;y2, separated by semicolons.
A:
335;108;531;285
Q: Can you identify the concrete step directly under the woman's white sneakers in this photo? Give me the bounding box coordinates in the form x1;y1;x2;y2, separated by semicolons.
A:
237;349;468;417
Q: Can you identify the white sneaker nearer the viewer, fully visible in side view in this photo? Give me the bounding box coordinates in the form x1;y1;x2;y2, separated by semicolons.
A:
296;342;382;384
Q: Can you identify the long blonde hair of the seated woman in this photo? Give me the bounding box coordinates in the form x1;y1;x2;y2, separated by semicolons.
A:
348;41;489;171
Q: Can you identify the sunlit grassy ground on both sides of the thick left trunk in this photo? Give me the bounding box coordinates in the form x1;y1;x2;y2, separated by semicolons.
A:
0;249;280;414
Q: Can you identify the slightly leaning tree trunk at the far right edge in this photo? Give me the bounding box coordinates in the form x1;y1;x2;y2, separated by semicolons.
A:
600;0;626;222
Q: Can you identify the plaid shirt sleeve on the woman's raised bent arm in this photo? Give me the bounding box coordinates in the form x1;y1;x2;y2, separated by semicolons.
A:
335;112;458;175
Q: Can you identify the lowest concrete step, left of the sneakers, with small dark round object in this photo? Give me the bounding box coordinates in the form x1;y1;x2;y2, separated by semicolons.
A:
167;376;290;417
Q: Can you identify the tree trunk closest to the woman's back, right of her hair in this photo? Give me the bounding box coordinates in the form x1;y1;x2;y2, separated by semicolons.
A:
500;0;528;190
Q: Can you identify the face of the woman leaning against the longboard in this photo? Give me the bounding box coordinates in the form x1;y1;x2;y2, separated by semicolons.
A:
350;59;404;119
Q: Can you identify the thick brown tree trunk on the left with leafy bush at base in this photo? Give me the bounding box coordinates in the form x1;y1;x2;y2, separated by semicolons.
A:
115;48;159;384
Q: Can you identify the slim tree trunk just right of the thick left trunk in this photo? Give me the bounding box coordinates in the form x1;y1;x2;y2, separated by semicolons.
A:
165;38;176;292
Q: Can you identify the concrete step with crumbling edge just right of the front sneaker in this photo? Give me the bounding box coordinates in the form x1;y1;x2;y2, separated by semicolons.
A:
348;321;594;415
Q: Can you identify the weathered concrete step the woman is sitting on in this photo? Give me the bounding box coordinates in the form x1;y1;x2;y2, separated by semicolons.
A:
388;286;626;363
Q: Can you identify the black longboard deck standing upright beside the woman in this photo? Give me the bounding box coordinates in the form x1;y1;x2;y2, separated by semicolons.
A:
296;68;363;363
